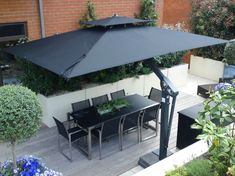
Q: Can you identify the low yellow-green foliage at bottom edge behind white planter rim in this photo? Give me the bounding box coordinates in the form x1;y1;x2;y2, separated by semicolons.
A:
166;159;215;176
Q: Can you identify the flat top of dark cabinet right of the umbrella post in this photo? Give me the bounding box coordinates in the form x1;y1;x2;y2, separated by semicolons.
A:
178;103;203;119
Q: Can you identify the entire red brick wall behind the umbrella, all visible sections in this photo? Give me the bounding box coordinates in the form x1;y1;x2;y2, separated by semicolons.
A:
0;0;190;40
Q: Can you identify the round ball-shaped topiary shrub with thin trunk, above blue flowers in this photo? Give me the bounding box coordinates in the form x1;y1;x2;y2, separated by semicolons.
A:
0;85;42;166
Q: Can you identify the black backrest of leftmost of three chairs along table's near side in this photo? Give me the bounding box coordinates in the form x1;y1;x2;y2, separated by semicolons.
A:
102;118;121;138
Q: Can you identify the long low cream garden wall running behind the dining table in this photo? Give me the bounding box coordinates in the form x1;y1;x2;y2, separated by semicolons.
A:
38;64;188;127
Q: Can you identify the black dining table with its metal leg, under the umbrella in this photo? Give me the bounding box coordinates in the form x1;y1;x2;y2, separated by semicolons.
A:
70;94;160;160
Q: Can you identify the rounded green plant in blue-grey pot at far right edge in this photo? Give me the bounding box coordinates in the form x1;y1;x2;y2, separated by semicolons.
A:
223;42;235;78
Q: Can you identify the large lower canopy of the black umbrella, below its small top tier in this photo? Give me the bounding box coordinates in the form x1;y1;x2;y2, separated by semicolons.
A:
4;17;227;78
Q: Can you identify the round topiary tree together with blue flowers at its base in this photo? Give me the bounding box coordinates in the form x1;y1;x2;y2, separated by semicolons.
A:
0;85;61;176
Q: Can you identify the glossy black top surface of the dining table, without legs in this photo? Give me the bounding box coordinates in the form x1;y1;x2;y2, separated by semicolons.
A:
71;94;160;128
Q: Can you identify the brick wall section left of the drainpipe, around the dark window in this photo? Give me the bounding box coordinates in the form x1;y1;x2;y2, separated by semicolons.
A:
0;0;40;40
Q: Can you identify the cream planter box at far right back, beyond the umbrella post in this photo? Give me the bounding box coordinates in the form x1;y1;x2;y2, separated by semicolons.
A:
190;55;224;81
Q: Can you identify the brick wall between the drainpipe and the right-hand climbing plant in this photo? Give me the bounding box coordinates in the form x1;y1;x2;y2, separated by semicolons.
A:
44;0;140;36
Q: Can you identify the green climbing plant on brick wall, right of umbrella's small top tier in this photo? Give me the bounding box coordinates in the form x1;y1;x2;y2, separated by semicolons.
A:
135;0;158;26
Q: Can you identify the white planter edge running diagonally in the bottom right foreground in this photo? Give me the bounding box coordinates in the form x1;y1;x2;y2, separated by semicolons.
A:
134;140;208;176
